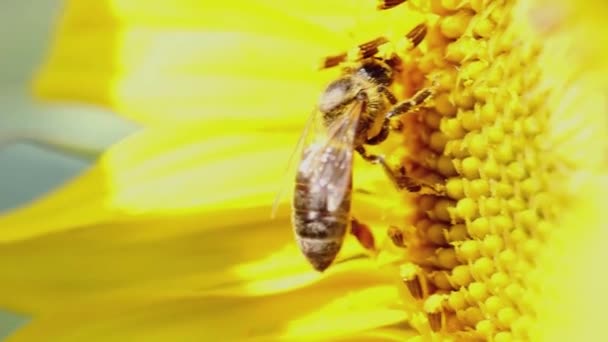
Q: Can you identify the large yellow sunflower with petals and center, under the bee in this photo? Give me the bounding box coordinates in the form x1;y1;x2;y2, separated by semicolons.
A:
0;0;608;341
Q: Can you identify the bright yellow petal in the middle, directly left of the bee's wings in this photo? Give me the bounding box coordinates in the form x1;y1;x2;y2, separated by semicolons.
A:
0;121;298;241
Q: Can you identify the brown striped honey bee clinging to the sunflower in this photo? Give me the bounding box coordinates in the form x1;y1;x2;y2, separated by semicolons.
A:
292;24;433;271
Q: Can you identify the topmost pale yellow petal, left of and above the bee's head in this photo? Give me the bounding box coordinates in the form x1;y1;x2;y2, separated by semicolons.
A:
34;0;422;124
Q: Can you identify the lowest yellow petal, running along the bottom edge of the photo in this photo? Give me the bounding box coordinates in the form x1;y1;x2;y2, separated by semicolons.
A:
8;265;407;342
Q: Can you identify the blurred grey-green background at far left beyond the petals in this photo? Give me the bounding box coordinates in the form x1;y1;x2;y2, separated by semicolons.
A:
0;0;137;340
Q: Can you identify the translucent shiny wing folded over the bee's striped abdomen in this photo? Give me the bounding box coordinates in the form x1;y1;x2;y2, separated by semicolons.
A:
298;100;364;211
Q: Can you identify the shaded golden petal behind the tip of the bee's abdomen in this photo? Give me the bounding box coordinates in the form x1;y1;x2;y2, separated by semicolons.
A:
0;188;400;314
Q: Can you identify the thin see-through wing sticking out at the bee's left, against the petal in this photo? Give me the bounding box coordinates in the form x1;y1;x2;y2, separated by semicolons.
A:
271;110;325;218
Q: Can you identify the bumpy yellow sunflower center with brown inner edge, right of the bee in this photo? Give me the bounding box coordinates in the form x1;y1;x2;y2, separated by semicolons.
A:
389;0;555;341
